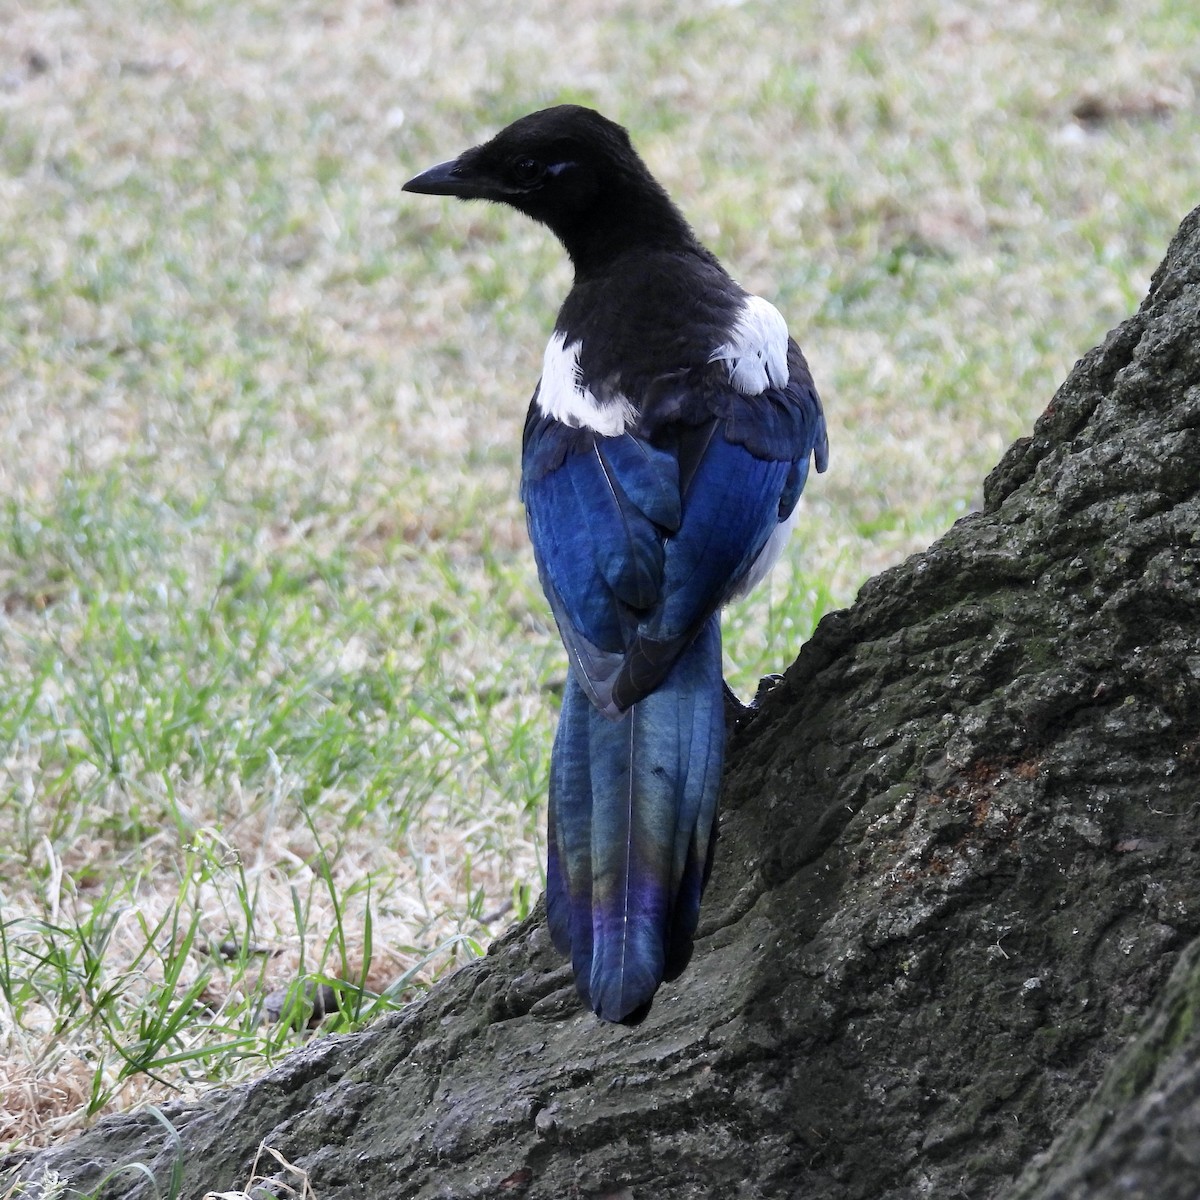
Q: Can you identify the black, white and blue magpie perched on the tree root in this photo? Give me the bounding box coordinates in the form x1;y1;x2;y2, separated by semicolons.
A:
403;104;828;1025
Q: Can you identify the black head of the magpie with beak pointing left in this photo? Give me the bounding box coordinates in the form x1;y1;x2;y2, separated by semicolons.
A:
404;104;692;268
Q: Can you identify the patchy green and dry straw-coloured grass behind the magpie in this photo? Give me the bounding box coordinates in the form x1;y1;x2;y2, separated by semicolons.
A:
0;0;1200;1166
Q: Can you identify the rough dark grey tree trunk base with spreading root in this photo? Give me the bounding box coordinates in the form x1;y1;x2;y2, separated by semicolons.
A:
7;209;1200;1200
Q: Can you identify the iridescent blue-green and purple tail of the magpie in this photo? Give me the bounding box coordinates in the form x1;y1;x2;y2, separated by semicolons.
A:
546;617;725;1021
